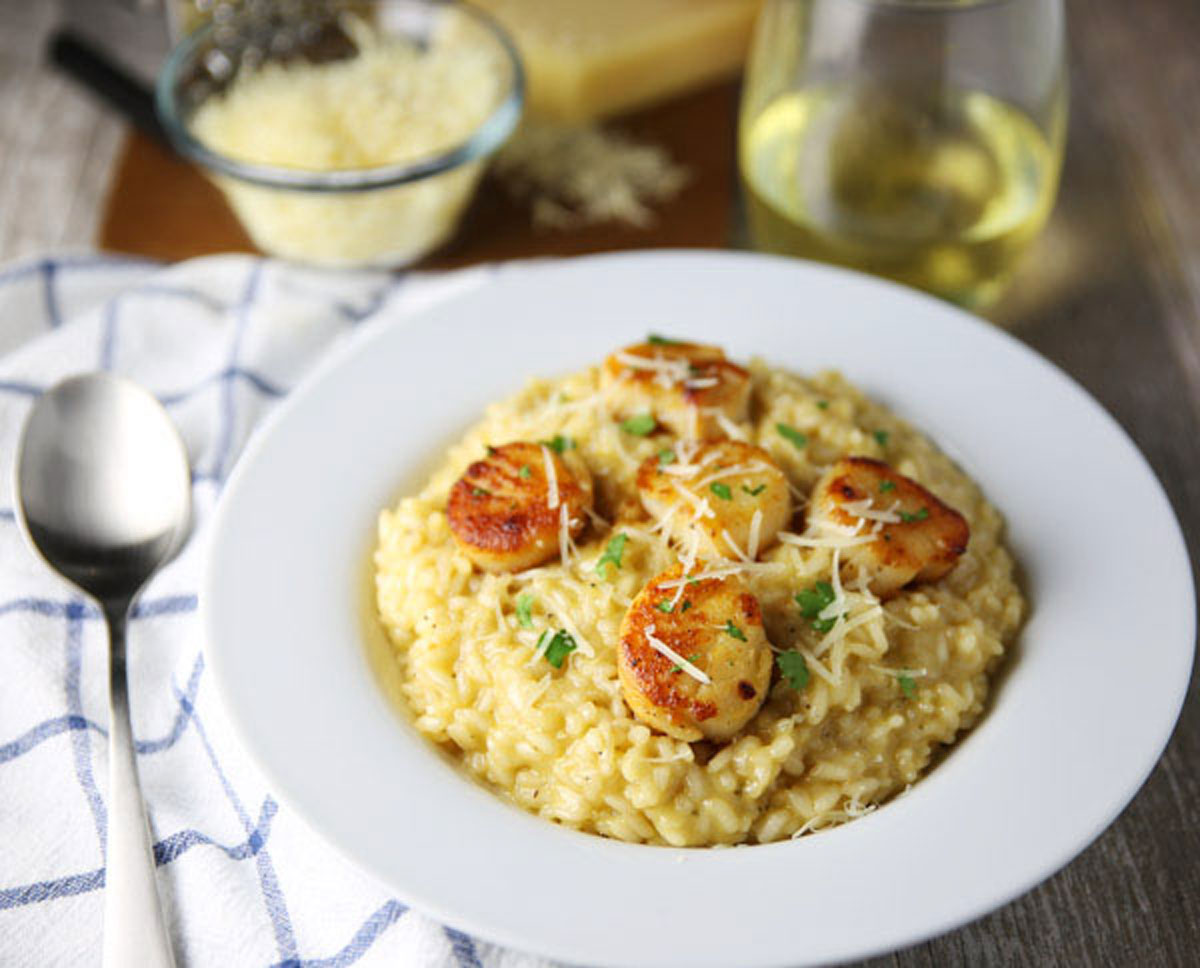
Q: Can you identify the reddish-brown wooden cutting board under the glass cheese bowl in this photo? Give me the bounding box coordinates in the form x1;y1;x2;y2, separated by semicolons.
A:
98;84;737;269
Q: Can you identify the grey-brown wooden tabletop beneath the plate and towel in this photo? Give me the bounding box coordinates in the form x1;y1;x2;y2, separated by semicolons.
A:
0;0;1200;966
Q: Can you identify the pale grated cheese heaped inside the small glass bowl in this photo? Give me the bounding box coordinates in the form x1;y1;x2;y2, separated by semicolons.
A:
190;17;510;266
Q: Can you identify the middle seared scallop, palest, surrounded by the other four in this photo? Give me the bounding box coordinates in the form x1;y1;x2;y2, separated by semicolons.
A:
637;440;792;560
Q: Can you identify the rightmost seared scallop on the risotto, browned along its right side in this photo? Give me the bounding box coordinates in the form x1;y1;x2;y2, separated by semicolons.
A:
809;457;971;599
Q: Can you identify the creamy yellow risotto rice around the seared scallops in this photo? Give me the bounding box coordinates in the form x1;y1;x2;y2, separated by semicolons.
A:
374;362;1024;846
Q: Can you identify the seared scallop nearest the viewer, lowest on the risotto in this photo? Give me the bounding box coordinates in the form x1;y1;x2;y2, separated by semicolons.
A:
617;565;772;742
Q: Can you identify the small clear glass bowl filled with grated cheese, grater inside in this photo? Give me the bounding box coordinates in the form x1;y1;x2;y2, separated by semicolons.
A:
156;0;523;267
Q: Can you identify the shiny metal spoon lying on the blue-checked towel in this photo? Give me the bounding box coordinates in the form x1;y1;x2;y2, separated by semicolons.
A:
16;373;191;968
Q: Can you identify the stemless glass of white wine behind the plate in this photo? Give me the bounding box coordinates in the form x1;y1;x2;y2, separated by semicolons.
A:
738;0;1067;306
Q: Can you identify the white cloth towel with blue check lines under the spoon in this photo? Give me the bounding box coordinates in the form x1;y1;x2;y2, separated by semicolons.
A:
0;255;544;968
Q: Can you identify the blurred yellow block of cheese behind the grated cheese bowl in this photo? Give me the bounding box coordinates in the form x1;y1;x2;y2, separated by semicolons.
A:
474;0;761;121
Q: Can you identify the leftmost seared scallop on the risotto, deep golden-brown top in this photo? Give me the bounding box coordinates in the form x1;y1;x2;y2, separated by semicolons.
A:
446;441;592;571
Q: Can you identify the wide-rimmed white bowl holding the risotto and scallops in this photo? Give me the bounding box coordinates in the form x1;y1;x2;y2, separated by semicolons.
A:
202;252;1195;968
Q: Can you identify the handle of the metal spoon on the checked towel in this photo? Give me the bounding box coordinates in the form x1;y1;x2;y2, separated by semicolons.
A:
103;602;175;968
